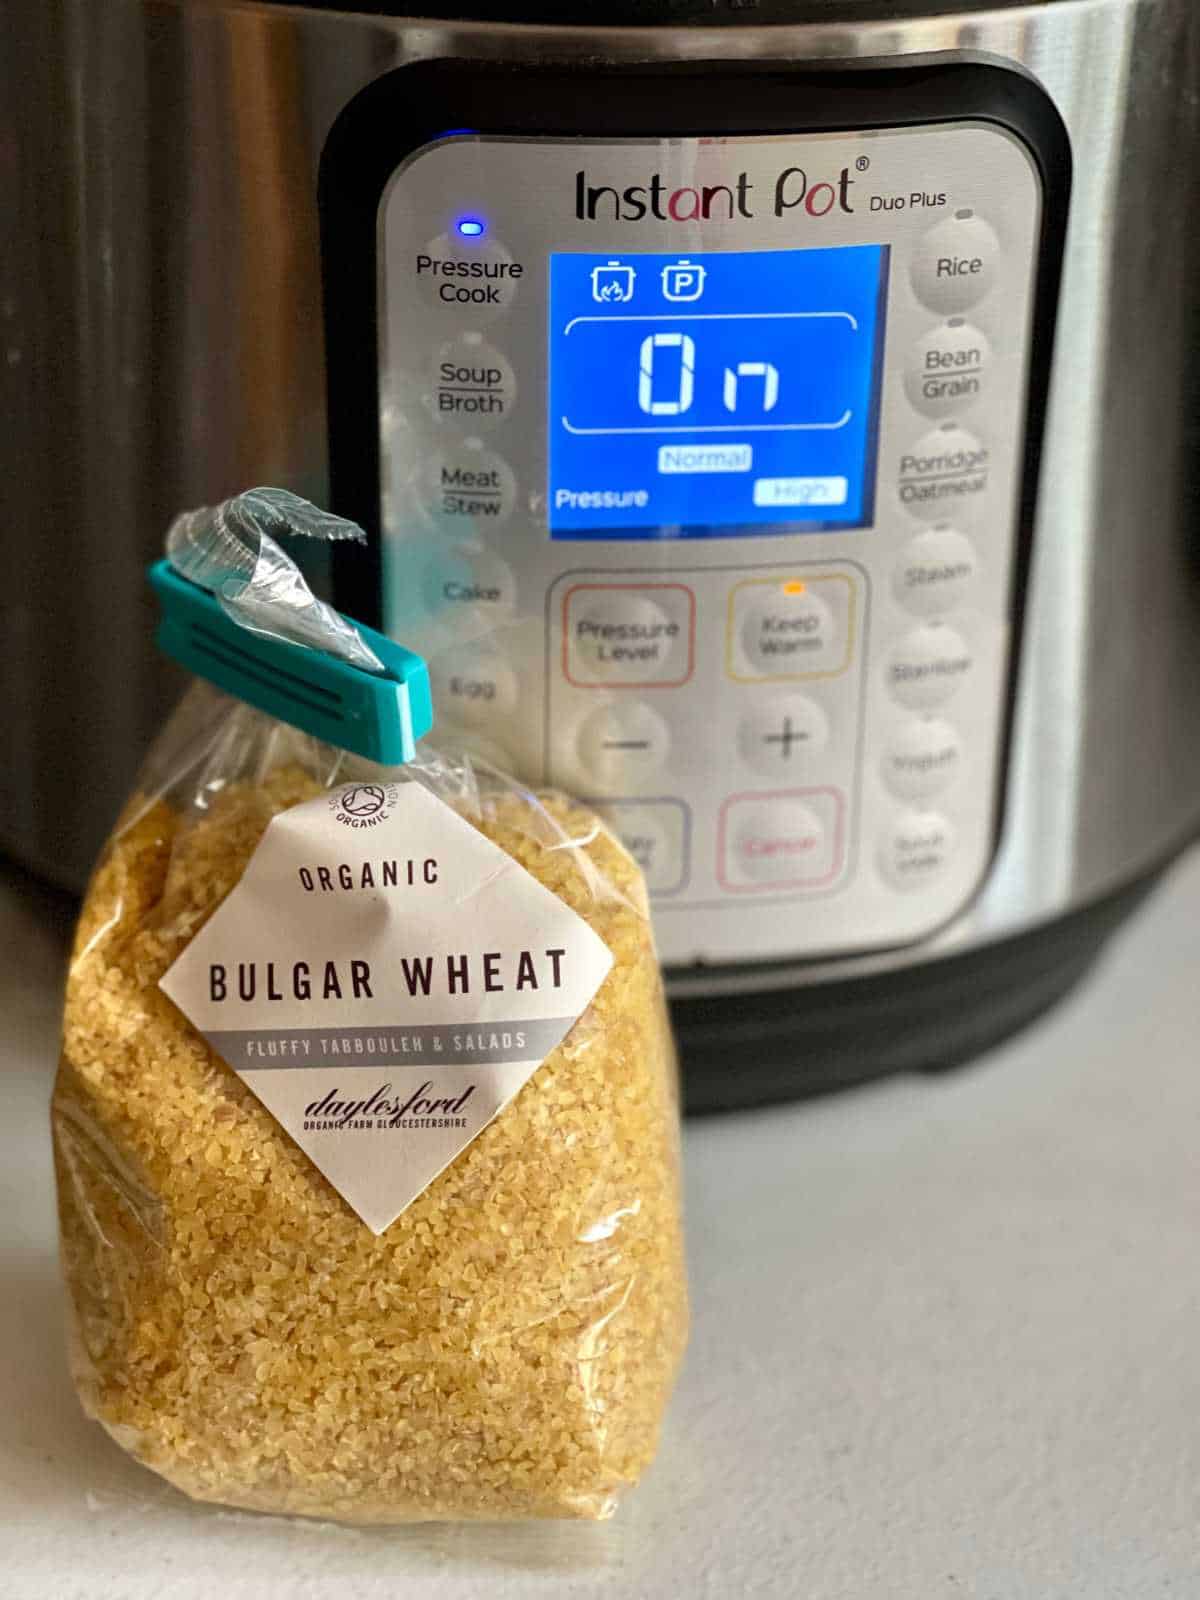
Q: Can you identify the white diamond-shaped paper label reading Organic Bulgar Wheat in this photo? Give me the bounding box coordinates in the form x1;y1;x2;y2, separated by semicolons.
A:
162;782;613;1234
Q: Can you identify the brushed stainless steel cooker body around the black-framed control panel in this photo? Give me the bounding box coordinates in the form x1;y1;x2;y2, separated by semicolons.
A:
0;0;1200;1017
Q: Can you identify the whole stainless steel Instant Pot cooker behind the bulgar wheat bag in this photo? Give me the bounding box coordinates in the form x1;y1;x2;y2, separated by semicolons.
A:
0;0;1200;1106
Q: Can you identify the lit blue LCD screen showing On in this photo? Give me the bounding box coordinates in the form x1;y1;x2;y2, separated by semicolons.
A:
547;245;888;539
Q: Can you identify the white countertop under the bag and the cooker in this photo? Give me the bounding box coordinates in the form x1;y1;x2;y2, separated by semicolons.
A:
0;854;1200;1600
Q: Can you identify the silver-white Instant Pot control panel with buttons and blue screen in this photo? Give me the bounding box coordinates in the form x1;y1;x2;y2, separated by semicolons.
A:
356;120;1042;963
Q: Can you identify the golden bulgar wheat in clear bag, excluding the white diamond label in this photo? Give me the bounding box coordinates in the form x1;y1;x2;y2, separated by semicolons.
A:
53;496;686;1523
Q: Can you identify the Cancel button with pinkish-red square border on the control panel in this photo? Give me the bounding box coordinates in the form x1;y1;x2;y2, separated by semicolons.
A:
717;789;842;894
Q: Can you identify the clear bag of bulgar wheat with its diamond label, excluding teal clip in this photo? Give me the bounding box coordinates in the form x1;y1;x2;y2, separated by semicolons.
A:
53;496;686;1523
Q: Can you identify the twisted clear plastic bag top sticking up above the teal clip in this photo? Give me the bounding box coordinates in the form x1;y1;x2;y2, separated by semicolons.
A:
166;488;384;672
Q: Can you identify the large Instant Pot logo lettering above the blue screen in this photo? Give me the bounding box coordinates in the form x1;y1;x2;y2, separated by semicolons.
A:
574;166;854;222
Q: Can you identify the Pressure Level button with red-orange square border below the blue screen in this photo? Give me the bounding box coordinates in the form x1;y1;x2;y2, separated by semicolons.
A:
563;584;696;688
